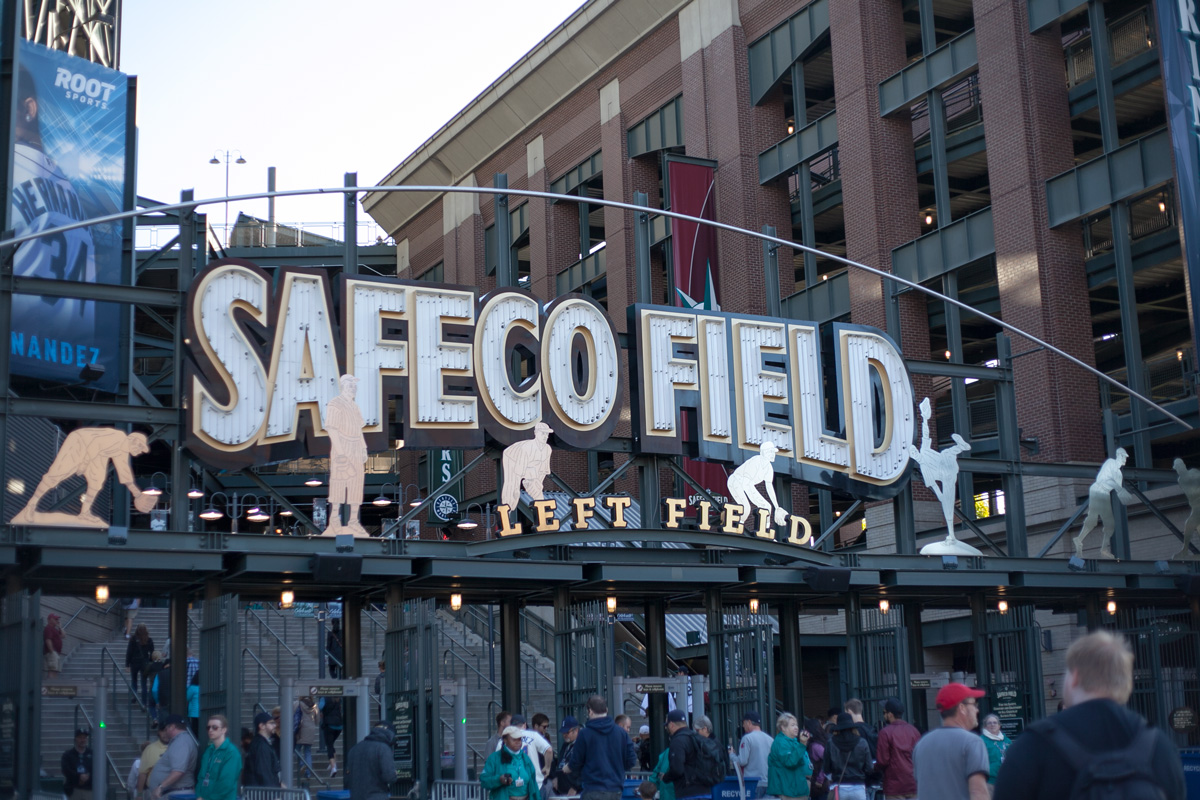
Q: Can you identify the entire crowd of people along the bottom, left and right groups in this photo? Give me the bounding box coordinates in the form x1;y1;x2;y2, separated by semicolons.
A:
51;626;1186;800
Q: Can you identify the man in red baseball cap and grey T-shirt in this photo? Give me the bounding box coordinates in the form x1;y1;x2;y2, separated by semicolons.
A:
912;684;989;800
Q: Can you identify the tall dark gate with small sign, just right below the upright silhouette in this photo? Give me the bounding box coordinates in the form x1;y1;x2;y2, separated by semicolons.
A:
383;600;443;798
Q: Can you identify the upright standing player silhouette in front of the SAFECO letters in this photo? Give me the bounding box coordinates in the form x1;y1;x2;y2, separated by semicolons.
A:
324;375;370;536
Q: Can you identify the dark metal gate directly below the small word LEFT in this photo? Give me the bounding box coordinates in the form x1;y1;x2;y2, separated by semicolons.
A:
554;601;609;720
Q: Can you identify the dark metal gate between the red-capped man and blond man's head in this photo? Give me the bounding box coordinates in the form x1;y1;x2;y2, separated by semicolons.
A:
976;603;1045;736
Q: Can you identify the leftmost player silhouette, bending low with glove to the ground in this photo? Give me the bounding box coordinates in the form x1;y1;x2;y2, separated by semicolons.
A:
10;428;156;528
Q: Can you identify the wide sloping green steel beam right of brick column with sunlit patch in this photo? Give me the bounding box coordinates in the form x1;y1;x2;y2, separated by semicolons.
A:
1046;130;1175;228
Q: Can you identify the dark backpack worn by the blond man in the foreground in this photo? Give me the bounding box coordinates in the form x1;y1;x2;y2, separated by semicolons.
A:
1043;717;1166;800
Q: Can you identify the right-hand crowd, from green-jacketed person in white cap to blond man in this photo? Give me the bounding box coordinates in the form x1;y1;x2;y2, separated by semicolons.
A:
480;632;1186;800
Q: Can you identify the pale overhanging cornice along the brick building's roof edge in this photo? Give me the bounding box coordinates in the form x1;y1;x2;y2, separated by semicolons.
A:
362;0;686;235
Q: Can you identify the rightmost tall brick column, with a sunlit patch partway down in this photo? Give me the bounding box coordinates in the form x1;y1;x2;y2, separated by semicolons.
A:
974;0;1103;462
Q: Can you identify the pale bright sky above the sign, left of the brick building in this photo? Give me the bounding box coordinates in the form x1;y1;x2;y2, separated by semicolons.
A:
120;0;582;236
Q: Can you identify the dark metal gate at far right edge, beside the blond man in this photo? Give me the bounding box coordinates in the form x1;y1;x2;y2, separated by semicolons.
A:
1109;608;1200;747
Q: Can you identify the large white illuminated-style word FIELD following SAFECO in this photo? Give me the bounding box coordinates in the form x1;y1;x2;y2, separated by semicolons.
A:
630;306;914;501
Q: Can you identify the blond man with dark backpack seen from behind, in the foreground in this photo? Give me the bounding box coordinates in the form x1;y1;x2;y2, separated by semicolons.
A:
993;631;1187;800
